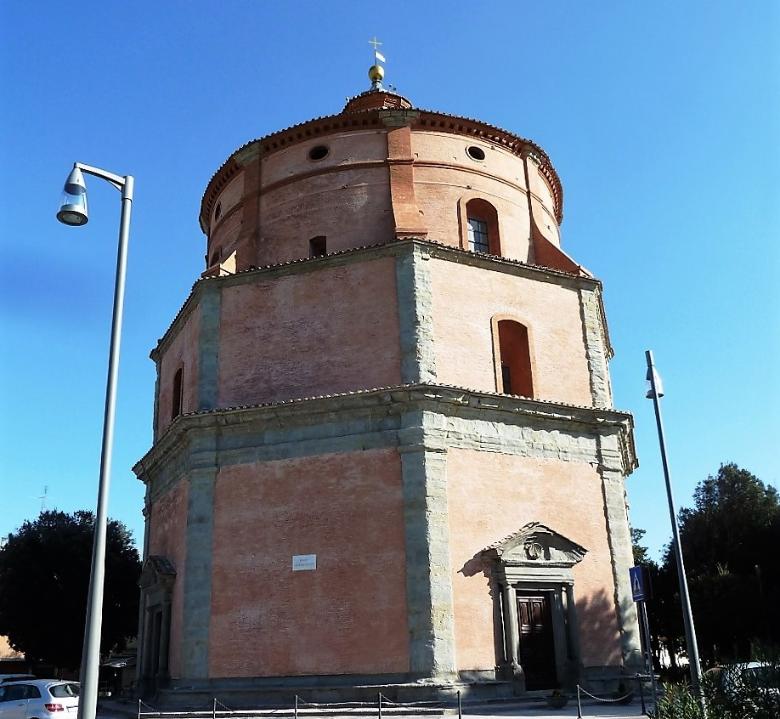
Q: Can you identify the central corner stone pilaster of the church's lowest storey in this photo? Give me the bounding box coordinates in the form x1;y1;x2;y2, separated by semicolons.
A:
398;412;456;680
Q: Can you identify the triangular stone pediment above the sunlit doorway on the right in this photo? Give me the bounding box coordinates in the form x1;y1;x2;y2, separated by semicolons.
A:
482;522;588;567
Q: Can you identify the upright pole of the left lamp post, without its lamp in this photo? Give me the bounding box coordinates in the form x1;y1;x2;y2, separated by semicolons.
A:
78;175;133;719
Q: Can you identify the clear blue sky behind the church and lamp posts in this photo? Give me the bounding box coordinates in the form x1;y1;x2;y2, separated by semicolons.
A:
0;0;780;564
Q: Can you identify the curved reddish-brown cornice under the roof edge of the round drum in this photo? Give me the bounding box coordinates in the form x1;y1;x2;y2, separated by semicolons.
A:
199;109;563;234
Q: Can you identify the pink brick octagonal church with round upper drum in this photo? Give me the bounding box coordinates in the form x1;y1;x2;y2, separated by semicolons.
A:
134;69;640;702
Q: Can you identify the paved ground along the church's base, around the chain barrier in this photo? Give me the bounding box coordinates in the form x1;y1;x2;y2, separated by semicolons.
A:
97;701;656;719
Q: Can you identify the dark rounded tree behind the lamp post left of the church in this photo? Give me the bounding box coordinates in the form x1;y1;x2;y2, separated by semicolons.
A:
0;511;141;669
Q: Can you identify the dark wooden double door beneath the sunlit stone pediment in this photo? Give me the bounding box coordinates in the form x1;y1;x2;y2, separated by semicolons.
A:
517;591;558;691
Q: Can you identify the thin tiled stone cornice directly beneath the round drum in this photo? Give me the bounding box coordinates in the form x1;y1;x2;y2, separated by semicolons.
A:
150;237;601;362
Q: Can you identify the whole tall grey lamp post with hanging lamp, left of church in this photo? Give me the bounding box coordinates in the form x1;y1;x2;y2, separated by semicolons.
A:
57;162;133;719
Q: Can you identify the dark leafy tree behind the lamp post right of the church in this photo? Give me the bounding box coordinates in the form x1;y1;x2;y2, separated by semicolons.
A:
648;464;780;663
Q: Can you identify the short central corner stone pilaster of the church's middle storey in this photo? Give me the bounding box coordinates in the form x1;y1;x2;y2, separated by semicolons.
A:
395;242;436;384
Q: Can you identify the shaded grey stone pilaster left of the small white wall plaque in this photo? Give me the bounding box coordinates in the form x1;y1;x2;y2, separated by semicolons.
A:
181;433;217;679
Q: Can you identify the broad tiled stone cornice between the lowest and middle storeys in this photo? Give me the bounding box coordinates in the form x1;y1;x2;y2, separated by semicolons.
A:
133;383;637;479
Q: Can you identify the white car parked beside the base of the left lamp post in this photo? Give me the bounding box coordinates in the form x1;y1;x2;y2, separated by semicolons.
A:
0;679;79;719
